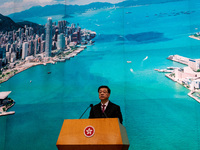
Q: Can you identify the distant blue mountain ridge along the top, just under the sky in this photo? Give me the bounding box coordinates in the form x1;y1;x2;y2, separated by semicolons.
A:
8;0;183;21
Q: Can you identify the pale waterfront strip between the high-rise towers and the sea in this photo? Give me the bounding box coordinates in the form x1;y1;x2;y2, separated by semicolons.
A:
0;46;87;84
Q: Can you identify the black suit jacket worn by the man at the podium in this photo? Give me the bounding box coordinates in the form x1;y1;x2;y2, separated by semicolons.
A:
89;101;123;124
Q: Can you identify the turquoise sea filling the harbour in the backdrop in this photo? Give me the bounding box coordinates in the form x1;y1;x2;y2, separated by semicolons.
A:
0;0;200;150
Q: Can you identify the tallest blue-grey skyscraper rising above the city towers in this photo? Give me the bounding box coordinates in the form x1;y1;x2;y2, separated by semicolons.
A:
45;18;52;57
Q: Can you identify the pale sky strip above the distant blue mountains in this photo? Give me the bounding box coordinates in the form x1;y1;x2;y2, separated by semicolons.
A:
0;0;125;15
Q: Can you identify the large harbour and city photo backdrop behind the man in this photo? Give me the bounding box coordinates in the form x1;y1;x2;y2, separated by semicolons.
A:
0;0;200;150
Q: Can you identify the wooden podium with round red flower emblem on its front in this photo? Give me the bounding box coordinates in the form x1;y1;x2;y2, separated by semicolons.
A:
56;118;130;150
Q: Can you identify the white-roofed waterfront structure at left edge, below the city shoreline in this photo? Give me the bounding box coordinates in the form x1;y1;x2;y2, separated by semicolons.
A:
0;91;15;116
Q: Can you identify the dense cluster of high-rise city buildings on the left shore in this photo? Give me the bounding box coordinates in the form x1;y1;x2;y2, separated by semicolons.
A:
0;17;96;82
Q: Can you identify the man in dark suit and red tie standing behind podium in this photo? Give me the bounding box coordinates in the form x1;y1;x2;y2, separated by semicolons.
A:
89;86;123;124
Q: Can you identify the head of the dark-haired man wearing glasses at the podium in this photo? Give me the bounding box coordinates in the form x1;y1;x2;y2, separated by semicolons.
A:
98;85;111;102
